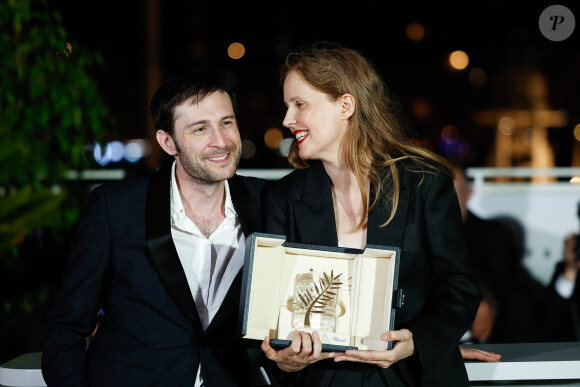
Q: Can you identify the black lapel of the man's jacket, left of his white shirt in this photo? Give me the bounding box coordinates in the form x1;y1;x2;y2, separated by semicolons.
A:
145;166;203;334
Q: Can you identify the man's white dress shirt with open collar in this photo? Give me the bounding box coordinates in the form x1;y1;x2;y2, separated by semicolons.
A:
170;162;246;386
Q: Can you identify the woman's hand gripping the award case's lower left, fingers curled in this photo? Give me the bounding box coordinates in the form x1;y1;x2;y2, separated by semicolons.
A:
262;331;335;372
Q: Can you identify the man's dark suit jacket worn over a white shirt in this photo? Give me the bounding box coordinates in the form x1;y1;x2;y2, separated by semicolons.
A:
41;167;264;386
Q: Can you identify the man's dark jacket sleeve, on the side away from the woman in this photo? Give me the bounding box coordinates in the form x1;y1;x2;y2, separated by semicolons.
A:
41;188;110;387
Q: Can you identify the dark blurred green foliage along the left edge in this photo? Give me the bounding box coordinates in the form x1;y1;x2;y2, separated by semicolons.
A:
0;0;111;363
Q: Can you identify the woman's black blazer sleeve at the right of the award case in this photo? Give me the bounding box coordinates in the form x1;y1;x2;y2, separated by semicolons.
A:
405;174;481;379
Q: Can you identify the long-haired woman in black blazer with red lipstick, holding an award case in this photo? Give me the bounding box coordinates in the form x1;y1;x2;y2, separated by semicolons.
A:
262;44;480;387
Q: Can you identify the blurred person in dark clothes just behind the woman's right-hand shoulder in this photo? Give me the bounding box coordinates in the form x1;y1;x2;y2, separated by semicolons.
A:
450;159;544;343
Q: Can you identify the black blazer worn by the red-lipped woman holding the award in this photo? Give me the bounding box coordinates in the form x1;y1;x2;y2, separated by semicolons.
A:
264;161;480;386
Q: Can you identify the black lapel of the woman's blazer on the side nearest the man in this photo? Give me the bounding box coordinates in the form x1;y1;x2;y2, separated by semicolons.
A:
294;161;338;246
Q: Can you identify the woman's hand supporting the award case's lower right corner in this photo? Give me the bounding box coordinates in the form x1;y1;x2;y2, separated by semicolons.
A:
334;329;415;368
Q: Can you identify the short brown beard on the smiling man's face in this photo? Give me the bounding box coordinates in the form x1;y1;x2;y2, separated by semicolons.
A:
176;143;242;184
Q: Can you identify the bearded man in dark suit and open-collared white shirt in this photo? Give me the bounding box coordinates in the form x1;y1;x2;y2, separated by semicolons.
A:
42;70;264;386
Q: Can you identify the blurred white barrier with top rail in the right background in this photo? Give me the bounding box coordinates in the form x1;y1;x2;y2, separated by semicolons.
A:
467;168;580;284
